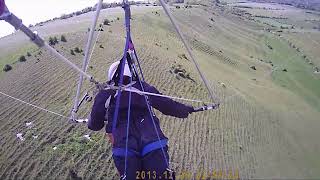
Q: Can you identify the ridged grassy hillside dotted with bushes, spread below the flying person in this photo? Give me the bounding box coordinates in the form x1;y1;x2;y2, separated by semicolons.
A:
0;2;320;179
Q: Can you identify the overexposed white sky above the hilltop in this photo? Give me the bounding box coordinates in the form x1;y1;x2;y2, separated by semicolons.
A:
0;0;120;37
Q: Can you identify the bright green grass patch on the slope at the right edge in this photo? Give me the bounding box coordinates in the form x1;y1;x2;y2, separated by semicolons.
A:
265;34;320;111
